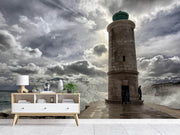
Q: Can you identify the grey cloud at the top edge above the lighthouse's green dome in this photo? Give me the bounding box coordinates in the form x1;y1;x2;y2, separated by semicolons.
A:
100;0;178;19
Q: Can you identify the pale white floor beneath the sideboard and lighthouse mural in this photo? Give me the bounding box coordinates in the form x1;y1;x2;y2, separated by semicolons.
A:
0;119;180;135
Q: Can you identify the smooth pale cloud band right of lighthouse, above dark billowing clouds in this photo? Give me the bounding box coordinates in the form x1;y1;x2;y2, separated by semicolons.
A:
136;32;180;57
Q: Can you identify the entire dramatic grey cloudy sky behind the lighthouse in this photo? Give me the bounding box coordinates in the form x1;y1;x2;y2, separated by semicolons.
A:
0;0;180;92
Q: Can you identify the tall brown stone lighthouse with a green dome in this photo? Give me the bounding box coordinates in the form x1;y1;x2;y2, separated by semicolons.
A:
107;11;142;104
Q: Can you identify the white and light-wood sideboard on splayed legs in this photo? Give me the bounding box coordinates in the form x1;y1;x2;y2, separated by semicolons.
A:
11;93;80;126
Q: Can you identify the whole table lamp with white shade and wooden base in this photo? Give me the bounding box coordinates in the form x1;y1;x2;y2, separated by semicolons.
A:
16;75;29;93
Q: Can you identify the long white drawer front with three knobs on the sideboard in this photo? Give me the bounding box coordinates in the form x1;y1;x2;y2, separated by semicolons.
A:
12;103;79;113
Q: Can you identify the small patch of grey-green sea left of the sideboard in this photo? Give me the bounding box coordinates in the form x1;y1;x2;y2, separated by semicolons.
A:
0;92;12;112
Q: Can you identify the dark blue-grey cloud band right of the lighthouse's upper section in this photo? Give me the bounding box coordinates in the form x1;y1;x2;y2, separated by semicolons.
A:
136;5;180;45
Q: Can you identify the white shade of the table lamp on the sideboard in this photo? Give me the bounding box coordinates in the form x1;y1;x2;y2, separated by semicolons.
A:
16;75;29;85
